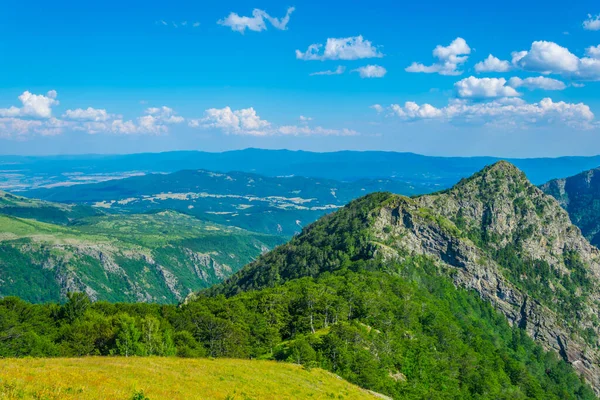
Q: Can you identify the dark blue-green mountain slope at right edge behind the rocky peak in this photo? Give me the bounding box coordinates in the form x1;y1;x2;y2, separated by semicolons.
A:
540;168;600;247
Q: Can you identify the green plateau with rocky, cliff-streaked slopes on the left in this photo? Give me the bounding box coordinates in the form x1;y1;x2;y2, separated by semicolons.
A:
0;193;282;303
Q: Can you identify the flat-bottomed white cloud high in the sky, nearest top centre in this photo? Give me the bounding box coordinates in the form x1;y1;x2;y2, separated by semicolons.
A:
296;35;383;61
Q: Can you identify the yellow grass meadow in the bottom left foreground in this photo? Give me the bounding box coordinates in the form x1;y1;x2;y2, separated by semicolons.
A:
0;357;384;400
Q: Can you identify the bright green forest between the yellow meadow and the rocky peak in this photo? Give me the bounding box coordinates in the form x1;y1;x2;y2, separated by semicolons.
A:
0;258;595;399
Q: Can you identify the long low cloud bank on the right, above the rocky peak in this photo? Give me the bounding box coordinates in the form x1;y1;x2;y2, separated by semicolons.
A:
378;98;594;128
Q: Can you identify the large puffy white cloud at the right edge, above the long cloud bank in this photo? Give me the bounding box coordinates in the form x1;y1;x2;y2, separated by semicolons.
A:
513;41;600;81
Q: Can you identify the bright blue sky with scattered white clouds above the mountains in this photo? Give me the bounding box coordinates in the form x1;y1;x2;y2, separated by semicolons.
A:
0;0;600;157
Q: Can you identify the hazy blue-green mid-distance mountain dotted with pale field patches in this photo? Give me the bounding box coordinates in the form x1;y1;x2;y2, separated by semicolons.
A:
18;170;419;236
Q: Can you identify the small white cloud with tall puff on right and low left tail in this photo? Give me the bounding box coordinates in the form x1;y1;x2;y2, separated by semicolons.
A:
405;37;471;75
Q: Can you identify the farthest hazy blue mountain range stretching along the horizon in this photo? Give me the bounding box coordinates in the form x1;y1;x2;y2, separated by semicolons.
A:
0;149;600;193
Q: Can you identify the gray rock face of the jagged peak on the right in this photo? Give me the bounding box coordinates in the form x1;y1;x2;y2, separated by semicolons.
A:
372;163;600;393
